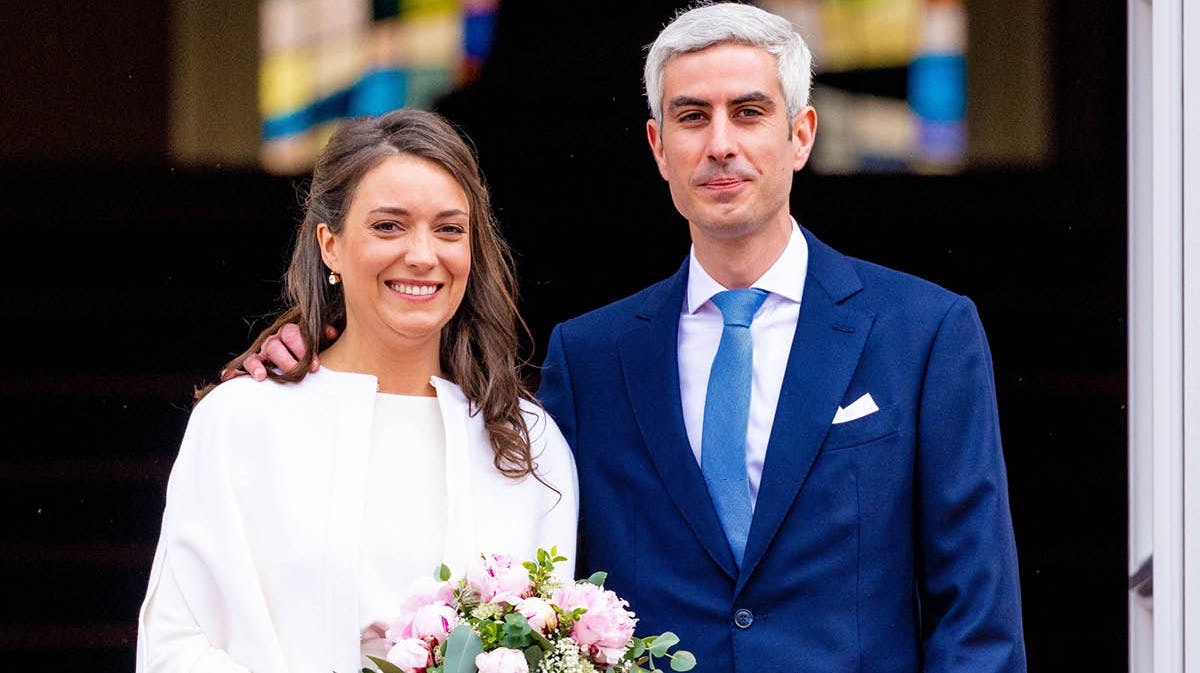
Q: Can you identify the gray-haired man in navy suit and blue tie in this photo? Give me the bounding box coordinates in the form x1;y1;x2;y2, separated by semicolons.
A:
241;4;1025;673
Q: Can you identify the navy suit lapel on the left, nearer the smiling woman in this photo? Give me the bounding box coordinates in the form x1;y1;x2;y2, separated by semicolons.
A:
620;262;737;578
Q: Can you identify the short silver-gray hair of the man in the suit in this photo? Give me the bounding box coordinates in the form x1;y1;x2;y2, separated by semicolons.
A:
644;2;812;124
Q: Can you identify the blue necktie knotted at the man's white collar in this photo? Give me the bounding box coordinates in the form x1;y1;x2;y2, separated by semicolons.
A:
700;288;767;566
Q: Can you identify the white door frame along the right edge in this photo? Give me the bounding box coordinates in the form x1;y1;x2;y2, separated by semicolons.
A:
1128;0;1200;673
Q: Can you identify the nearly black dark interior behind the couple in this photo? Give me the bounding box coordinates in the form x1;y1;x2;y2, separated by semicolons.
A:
0;0;1127;672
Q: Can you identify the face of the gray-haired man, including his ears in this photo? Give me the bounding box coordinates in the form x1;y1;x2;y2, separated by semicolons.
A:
647;44;816;248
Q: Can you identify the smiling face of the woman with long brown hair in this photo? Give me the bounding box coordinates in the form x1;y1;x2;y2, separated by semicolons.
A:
317;155;470;344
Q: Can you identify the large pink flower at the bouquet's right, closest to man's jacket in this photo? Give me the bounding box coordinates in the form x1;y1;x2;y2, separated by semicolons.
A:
554;582;637;666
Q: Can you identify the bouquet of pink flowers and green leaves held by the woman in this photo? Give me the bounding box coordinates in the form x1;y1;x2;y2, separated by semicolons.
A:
362;547;696;673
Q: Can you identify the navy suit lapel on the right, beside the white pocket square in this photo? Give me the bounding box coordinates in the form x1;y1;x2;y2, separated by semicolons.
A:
736;230;874;591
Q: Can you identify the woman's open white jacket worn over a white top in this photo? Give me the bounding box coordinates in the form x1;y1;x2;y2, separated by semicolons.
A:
137;369;578;673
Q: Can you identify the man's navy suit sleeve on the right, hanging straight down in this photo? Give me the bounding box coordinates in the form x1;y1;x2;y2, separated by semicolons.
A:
916;298;1025;673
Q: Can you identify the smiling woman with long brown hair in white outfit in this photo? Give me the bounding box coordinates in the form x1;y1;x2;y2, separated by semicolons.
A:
137;110;578;673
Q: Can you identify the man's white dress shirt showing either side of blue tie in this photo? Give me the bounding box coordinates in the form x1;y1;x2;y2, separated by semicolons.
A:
679;220;809;504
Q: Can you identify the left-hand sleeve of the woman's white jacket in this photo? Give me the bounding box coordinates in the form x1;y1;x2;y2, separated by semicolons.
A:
136;385;287;673
